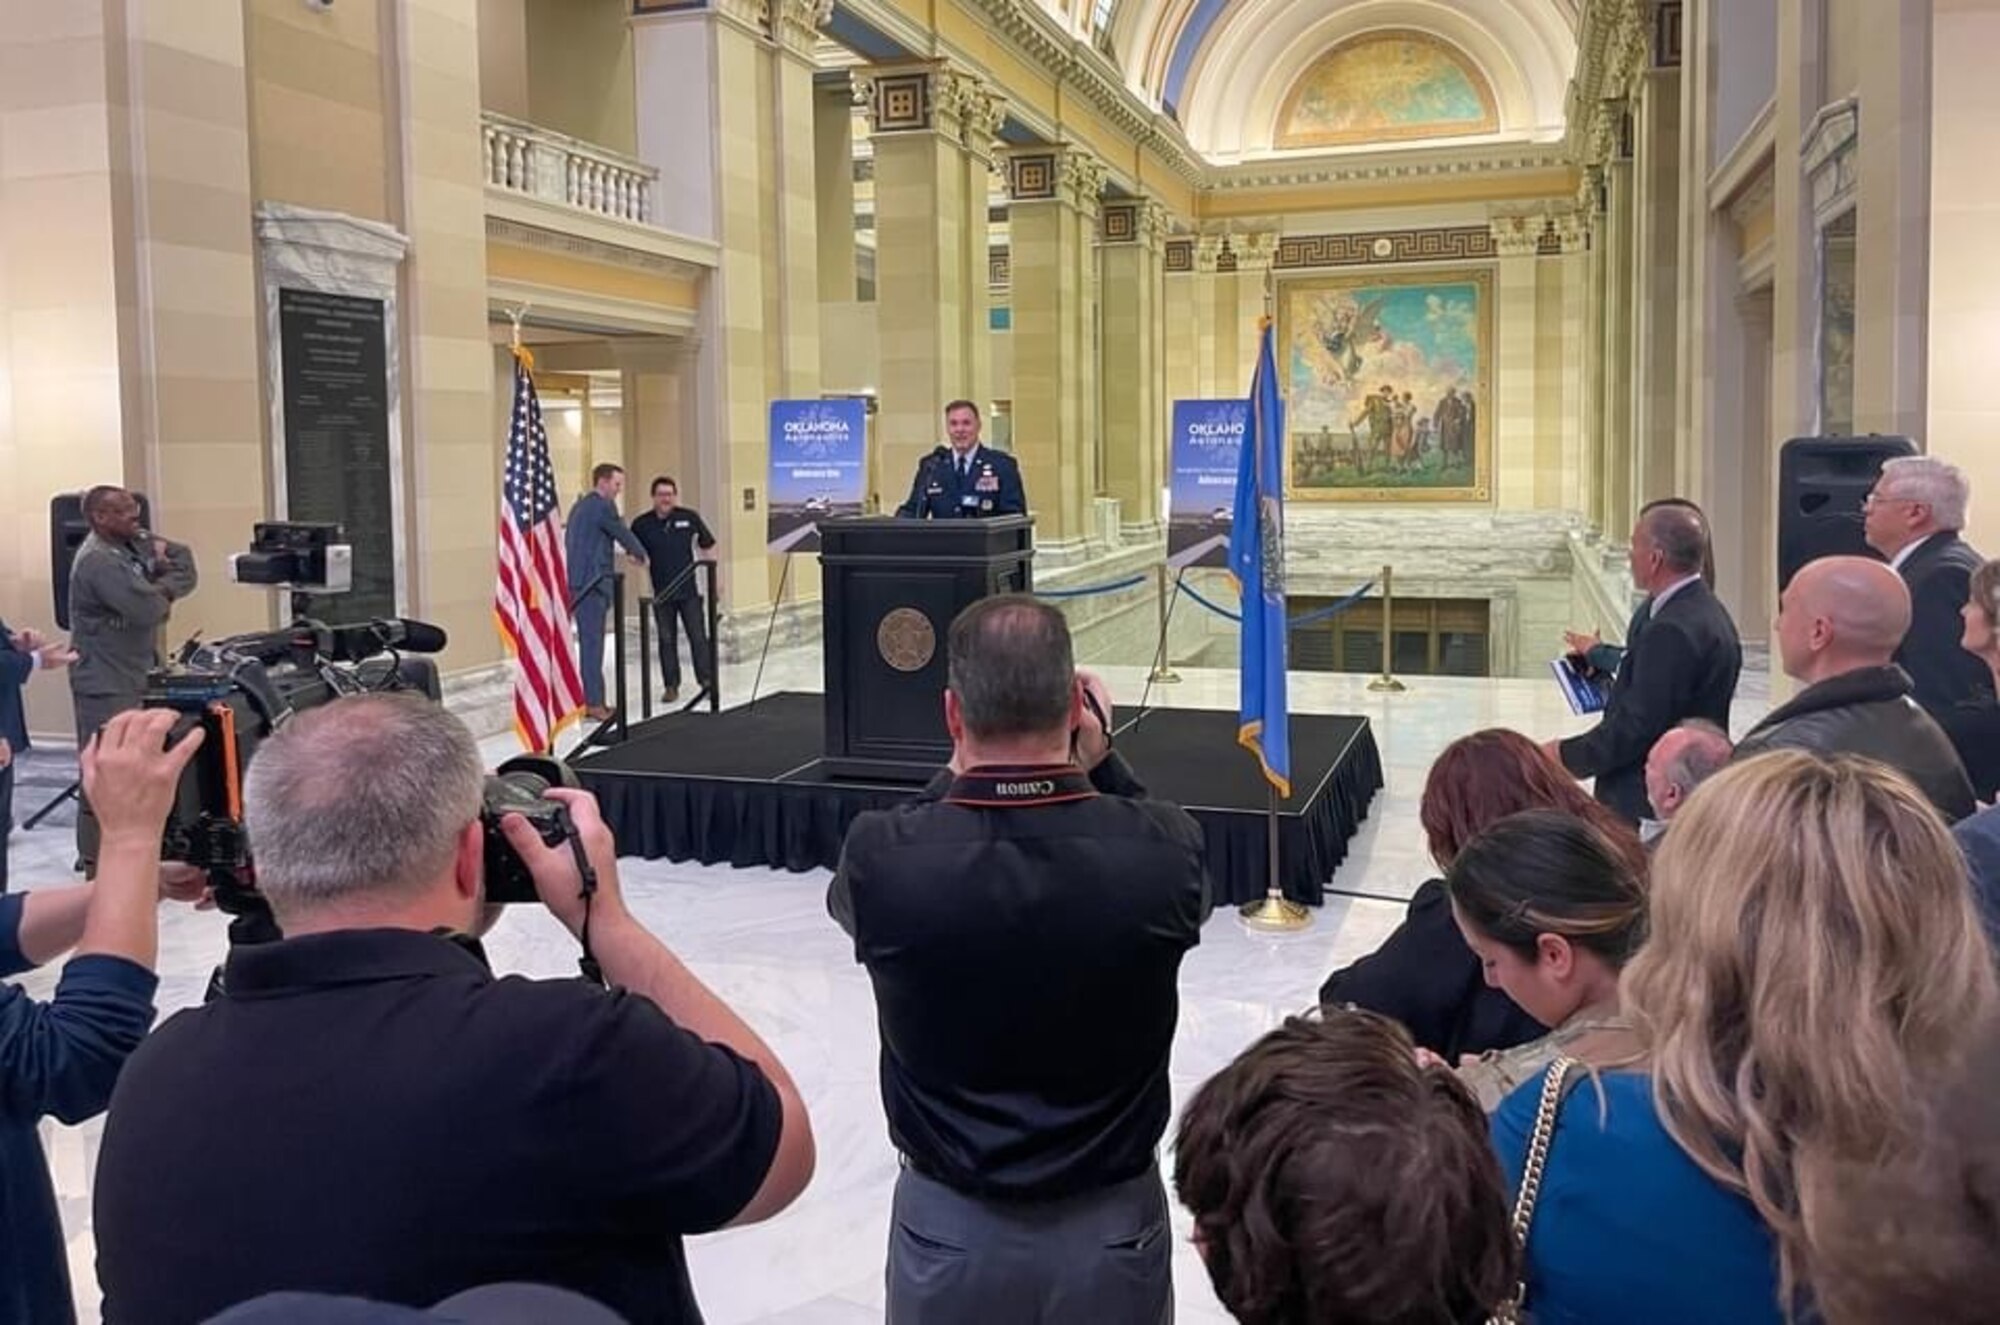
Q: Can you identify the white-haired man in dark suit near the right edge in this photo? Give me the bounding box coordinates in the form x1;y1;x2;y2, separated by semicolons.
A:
1862;456;1996;767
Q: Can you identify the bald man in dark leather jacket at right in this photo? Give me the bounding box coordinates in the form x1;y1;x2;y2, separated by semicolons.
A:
1736;556;1976;823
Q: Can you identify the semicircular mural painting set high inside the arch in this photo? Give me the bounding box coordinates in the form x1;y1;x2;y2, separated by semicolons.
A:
1278;30;1500;148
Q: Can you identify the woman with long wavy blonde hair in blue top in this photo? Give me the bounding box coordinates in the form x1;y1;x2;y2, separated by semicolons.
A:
1494;751;2000;1325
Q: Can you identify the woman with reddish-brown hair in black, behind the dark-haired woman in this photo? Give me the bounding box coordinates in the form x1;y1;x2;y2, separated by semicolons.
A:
1320;727;1646;1063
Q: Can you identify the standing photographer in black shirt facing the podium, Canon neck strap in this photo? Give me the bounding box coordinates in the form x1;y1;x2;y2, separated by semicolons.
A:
828;594;1210;1325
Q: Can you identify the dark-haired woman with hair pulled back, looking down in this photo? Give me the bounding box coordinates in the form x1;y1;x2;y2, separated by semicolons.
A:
1444;811;1646;1109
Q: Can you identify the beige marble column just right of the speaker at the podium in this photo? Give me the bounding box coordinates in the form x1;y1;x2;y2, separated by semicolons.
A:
1006;144;1106;558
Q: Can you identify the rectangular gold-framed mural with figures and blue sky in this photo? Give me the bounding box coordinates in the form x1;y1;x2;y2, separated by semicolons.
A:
1278;270;1492;502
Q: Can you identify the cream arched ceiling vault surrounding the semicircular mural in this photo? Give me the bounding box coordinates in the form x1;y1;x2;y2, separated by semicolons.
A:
1110;0;1578;162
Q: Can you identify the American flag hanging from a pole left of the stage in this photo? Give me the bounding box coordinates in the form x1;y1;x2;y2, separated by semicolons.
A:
494;350;584;751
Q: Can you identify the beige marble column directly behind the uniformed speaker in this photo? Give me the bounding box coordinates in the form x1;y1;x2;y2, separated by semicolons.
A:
864;60;1008;512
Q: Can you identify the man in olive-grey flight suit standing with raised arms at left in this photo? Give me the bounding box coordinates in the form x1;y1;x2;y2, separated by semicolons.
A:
70;484;196;875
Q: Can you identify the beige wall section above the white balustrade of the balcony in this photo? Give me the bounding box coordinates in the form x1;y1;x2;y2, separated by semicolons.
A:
528;0;638;156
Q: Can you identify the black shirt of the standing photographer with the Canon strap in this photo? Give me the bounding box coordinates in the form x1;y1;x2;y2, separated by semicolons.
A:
828;755;1210;1199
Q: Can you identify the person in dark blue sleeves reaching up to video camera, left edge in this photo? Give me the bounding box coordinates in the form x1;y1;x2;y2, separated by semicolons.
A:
0;713;202;1321
